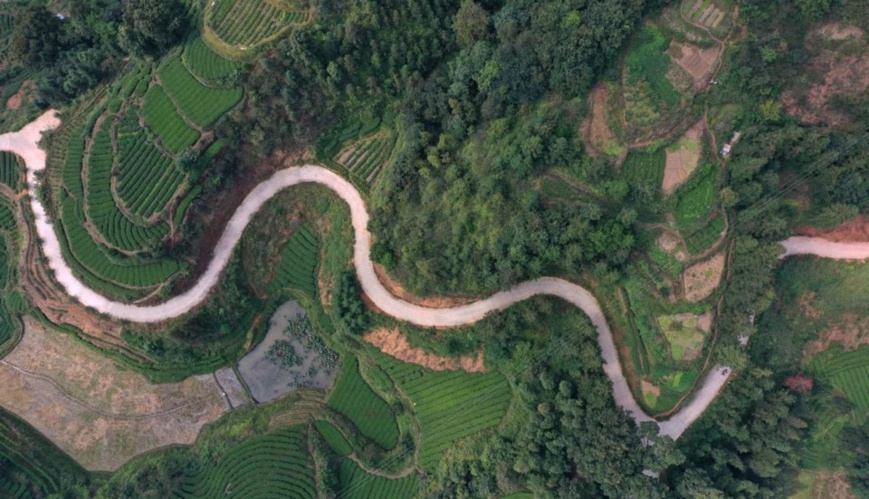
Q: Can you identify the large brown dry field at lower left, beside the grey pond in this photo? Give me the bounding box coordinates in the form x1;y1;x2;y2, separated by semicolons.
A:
0;318;227;471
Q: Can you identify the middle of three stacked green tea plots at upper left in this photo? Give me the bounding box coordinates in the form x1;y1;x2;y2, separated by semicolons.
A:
157;57;244;128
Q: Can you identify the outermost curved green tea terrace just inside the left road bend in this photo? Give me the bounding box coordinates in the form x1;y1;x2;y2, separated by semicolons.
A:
61;198;180;292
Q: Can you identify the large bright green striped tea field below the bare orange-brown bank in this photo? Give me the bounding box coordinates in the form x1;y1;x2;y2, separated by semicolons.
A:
375;353;512;472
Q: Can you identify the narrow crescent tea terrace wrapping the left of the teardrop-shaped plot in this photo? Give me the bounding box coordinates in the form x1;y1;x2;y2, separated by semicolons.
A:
87;116;169;251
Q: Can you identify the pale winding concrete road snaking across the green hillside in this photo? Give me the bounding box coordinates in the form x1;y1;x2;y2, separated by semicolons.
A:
0;111;869;439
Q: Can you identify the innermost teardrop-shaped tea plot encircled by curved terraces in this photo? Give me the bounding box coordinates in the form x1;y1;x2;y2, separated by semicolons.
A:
116;106;187;218
